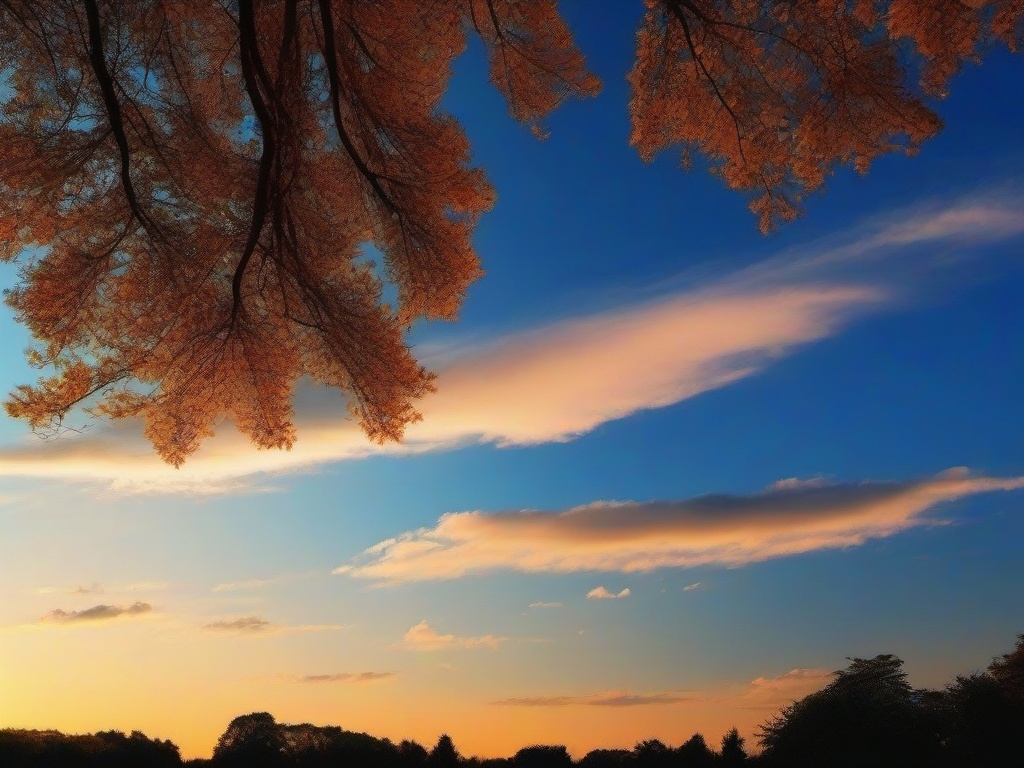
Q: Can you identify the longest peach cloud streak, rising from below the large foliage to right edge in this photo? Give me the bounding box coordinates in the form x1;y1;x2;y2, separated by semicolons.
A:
0;191;1024;493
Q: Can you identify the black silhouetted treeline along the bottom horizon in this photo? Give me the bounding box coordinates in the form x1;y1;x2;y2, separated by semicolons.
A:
0;635;1024;768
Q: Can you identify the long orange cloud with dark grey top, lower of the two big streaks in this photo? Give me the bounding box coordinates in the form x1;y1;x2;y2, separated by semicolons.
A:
334;469;1024;583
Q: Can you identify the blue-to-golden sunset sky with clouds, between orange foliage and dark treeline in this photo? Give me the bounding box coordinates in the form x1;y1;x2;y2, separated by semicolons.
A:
0;0;1024;757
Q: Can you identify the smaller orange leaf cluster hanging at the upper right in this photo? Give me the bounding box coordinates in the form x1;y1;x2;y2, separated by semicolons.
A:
630;0;1024;231
